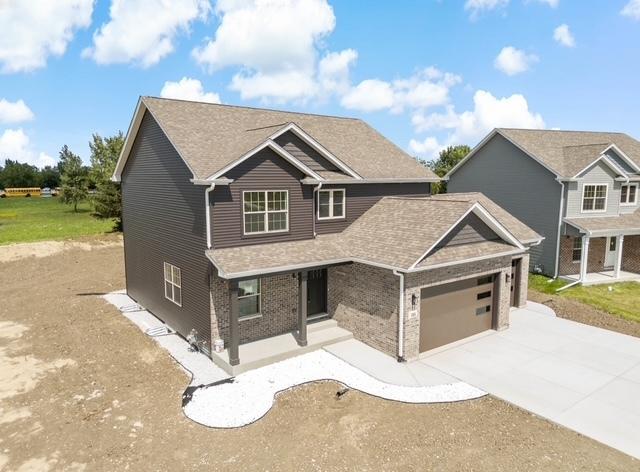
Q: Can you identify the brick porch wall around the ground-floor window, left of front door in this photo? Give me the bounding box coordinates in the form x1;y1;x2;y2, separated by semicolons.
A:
211;274;298;346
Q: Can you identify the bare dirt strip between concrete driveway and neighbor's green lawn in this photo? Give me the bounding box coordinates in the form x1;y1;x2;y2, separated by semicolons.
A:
528;290;640;338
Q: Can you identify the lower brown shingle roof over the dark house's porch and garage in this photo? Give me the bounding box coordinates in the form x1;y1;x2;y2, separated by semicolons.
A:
207;193;541;278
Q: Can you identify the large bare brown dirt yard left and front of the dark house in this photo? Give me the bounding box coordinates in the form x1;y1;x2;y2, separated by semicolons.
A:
0;240;640;472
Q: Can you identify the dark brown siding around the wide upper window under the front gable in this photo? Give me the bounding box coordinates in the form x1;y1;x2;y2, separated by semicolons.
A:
210;148;313;248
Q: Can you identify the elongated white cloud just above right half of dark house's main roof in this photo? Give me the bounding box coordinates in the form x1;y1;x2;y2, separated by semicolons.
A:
341;67;462;113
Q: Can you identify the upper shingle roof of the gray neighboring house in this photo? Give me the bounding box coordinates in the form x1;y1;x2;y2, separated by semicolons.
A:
498;128;640;178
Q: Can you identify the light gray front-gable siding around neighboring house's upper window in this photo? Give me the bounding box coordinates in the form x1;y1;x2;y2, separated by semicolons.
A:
565;162;620;218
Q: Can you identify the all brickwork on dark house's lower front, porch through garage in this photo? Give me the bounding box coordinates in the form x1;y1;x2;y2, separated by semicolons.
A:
211;254;528;360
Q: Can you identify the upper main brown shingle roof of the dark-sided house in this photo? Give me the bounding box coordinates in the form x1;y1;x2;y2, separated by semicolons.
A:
142;97;437;179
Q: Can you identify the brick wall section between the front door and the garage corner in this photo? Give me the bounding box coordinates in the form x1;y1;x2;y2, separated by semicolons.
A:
327;263;400;356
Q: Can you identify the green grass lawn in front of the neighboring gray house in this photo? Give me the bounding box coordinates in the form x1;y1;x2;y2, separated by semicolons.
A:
529;274;640;322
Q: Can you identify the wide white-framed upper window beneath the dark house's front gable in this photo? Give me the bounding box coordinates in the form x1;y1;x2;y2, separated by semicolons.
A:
243;190;289;234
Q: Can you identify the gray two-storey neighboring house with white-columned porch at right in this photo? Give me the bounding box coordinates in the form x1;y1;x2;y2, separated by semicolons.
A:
445;129;640;283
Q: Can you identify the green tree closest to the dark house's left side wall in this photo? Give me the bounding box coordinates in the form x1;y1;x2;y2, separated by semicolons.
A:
89;131;124;231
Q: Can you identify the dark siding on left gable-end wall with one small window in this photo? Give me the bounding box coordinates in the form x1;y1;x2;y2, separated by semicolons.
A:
122;112;211;347
